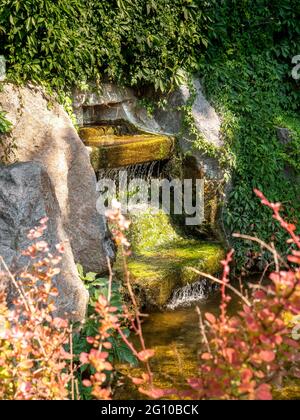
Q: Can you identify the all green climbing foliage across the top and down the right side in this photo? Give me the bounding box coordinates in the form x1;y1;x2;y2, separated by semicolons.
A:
0;0;300;262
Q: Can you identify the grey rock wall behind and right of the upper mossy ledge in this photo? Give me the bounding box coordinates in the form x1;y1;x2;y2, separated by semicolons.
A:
74;79;228;241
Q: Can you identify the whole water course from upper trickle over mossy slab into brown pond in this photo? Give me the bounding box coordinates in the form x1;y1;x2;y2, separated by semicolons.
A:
98;135;300;400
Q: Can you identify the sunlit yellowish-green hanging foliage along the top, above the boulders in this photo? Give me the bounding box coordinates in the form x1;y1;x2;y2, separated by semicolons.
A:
0;0;210;90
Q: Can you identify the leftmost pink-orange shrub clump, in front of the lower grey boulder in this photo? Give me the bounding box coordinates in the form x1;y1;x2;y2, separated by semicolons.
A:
0;220;71;400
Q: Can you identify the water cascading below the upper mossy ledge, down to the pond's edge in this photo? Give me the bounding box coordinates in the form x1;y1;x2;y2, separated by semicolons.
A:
98;161;218;310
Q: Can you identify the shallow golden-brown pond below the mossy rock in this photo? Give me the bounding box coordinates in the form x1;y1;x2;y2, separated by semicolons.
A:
114;286;300;400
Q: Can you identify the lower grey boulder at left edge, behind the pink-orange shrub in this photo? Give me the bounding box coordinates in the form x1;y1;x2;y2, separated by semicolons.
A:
0;162;88;321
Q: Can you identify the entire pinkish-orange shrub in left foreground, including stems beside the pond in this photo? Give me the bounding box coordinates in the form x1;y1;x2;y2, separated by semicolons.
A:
0;219;137;400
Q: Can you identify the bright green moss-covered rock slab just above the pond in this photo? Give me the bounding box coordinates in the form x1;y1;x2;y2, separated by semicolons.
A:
118;212;225;309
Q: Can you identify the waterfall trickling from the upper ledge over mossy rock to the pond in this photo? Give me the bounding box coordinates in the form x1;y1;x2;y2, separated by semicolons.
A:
98;161;218;310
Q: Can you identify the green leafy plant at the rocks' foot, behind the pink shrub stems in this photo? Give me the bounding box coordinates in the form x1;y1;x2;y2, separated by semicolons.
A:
73;264;137;400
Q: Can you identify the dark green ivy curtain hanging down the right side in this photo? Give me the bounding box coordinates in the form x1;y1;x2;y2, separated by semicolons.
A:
200;0;300;264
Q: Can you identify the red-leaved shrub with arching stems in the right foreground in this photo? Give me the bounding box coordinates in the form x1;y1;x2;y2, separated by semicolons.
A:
145;191;300;400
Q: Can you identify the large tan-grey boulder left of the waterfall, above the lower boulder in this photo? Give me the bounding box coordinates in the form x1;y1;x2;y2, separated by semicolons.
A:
0;84;113;273
